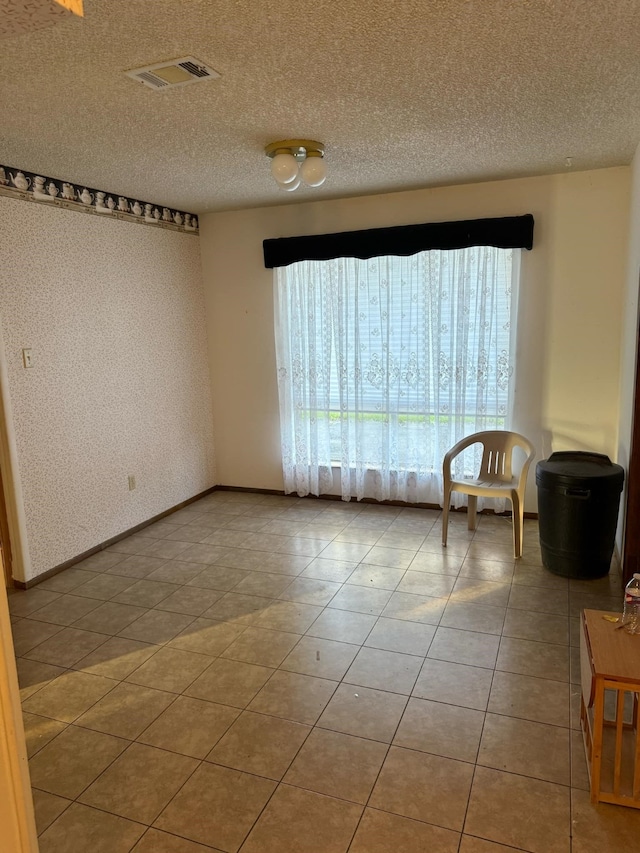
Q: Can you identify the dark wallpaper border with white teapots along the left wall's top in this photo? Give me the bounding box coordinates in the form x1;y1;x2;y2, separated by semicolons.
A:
0;165;198;234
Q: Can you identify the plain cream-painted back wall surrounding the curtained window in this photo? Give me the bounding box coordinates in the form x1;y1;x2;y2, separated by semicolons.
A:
200;167;630;510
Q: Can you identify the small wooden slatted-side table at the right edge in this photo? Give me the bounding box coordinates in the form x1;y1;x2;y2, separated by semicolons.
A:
580;610;640;808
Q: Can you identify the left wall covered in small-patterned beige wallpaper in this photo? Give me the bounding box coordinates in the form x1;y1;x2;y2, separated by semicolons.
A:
0;198;215;580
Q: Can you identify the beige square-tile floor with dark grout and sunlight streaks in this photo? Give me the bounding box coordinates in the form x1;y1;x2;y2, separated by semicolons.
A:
9;492;640;853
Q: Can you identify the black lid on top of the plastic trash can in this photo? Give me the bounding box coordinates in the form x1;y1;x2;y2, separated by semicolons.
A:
536;450;624;491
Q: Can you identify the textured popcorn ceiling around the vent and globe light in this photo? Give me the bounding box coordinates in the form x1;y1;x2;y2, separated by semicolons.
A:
0;0;640;213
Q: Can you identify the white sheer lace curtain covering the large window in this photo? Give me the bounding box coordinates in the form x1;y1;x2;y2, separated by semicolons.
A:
275;246;520;503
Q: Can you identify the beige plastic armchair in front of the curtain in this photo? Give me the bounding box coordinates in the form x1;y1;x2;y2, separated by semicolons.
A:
442;430;535;559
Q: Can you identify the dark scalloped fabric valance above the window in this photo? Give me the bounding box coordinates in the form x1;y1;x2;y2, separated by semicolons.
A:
263;213;533;269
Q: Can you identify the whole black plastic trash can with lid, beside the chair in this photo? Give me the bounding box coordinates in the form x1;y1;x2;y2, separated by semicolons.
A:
536;450;624;580
